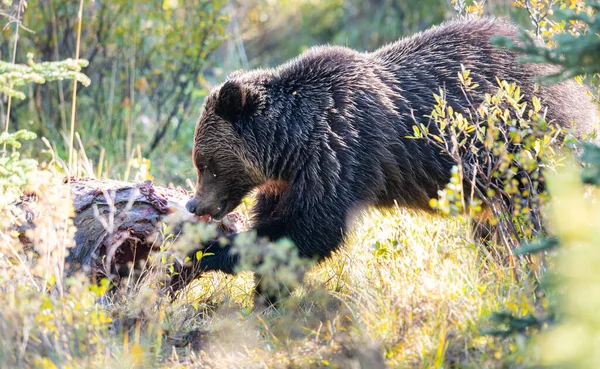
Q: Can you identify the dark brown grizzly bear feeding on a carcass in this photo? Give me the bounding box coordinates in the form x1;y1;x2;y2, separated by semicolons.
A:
173;19;597;294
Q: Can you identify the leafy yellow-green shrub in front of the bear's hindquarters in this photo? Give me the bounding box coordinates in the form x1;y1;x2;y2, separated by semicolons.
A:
411;70;570;244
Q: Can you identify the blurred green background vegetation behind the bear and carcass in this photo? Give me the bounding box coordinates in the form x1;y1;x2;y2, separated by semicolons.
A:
0;0;544;185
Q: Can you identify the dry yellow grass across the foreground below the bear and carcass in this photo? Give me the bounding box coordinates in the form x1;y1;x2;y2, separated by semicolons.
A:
0;162;531;368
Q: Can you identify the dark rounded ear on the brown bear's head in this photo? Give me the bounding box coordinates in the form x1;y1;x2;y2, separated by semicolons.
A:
215;80;258;123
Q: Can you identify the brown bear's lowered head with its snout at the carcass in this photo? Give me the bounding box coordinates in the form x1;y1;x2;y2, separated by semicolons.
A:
186;77;266;219
